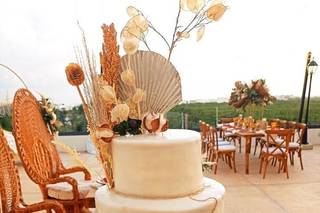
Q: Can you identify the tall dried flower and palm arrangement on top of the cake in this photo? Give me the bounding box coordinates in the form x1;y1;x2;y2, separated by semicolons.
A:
65;0;227;188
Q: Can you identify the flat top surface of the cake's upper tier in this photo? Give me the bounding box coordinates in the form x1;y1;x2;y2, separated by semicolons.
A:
113;129;200;144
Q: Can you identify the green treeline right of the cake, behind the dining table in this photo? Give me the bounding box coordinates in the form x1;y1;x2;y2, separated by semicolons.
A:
167;96;320;128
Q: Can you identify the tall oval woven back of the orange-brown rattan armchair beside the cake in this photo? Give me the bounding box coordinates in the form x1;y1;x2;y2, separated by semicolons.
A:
13;89;61;185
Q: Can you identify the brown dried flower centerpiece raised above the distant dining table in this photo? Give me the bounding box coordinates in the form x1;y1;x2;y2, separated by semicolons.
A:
229;79;276;117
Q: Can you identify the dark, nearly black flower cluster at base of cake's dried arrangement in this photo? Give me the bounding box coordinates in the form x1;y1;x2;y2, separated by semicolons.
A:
112;118;142;136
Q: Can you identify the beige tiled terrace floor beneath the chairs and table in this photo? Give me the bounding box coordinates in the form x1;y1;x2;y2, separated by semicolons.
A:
19;146;320;213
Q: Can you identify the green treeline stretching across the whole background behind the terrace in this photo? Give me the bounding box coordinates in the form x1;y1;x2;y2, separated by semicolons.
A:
0;97;320;132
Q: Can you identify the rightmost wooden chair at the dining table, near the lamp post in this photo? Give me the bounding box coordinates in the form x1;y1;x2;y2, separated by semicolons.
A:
289;123;306;170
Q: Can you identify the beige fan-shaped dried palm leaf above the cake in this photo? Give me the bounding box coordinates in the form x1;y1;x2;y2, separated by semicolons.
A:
118;51;182;115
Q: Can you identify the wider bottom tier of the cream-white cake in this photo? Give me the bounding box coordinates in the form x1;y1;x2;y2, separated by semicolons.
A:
95;178;225;213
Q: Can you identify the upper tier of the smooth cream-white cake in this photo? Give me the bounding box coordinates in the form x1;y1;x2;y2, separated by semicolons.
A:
112;129;203;198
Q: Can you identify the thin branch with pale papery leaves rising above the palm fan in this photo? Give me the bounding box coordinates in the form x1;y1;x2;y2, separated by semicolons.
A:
121;0;227;60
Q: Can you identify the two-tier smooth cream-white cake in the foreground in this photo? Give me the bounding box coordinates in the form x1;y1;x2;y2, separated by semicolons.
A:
96;130;224;213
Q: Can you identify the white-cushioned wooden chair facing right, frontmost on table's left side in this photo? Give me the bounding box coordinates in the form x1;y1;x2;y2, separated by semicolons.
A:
207;127;237;174
